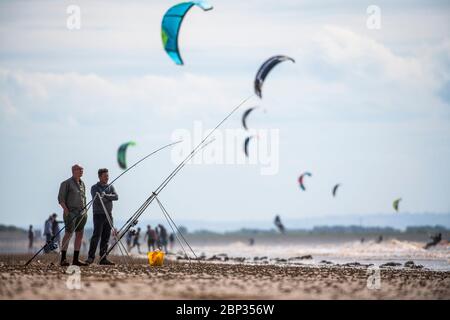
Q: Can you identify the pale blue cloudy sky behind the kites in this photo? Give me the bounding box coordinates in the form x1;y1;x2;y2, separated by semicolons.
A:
0;0;450;228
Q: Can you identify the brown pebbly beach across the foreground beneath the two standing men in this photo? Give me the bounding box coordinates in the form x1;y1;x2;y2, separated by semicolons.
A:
0;255;450;300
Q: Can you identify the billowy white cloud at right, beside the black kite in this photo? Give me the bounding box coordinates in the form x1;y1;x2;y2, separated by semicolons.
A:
272;25;449;120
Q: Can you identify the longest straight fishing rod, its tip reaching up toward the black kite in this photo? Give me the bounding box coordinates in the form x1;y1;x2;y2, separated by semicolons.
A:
100;94;254;259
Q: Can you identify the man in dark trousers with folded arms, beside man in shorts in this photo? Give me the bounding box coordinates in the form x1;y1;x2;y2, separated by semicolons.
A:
86;168;119;265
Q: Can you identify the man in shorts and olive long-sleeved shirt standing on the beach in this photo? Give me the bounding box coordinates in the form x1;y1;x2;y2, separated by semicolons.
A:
58;164;87;266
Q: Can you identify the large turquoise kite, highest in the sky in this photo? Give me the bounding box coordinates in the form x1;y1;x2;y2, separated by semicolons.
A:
161;0;213;65
